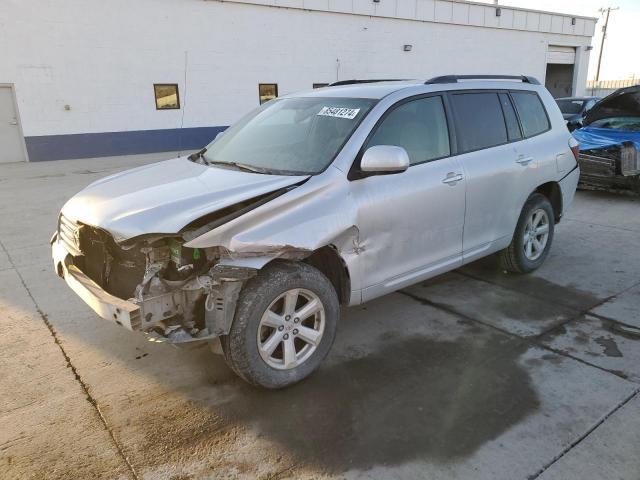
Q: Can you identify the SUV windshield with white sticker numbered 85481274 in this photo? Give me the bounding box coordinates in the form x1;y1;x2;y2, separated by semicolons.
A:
204;97;375;175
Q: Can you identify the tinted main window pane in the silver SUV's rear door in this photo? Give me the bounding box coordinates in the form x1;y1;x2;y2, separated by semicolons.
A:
451;92;507;153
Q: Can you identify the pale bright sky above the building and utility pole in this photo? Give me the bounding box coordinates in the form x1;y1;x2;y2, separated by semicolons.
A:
480;0;640;80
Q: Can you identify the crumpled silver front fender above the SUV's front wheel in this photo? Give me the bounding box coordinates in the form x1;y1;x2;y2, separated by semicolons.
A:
185;167;365;296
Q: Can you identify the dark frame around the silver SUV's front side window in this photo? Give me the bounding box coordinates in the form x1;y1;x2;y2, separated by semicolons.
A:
347;91;458;181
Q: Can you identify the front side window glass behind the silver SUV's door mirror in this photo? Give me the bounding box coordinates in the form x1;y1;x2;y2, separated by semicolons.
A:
367;97;450;165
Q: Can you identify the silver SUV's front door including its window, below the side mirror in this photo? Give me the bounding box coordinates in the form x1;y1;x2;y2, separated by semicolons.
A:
351;96;465;301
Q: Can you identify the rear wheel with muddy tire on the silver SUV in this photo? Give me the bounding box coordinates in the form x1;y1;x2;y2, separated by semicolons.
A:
500;193;555;273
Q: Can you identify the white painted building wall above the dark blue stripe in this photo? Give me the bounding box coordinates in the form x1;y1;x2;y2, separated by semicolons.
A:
0;0;595;159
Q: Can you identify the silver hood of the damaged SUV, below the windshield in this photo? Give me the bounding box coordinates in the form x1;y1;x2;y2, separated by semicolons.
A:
62;157;308;242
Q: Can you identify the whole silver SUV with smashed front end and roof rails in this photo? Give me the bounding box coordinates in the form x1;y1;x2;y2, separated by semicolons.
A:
51;76;579;388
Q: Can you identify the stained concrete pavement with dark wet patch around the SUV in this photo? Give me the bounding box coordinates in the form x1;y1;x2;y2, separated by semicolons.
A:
0;155;640;480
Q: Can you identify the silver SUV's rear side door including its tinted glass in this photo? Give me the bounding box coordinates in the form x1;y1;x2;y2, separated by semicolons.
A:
450;90;536;261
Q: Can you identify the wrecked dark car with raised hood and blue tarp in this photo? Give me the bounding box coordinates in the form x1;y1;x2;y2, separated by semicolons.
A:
572;85;640;194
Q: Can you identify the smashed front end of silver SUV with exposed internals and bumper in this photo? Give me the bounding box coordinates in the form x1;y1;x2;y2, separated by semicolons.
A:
52;215;256;343
